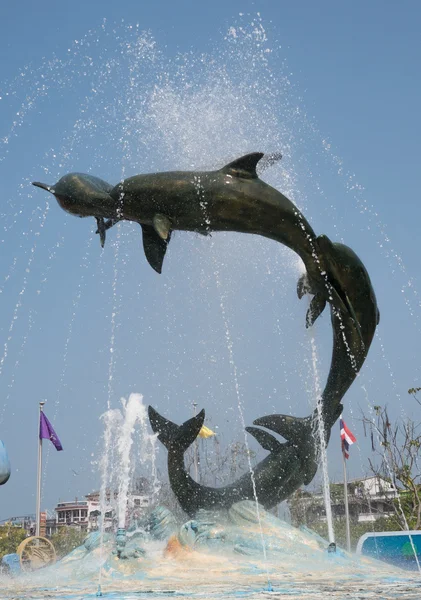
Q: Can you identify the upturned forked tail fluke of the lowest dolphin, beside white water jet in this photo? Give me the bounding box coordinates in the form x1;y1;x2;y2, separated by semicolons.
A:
148;406;205;452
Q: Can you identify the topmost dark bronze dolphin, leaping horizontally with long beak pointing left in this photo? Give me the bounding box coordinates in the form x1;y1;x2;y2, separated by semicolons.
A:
34;152;354;326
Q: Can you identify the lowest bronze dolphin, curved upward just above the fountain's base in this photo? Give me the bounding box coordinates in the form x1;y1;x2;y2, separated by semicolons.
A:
148;406;342;517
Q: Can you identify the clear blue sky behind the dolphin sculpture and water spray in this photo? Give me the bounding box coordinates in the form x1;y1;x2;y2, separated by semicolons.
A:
0;0;421;518
